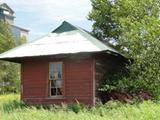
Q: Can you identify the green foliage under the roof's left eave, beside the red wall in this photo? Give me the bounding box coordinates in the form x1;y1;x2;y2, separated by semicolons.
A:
0;61;20;93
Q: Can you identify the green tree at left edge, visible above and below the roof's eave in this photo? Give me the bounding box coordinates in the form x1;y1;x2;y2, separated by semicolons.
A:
0;21;24;94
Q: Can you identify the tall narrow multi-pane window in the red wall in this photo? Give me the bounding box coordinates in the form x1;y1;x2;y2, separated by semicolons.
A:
49;62;62;97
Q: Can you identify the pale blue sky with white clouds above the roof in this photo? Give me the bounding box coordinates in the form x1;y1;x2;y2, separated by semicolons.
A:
0;0;92;41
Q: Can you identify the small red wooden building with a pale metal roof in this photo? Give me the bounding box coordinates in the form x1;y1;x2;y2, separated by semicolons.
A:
0;22;124;105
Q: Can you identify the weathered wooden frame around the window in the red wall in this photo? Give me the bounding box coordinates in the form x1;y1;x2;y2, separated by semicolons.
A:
48;61;64;99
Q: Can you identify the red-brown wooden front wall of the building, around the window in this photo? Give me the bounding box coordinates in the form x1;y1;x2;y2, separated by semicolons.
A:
21;58;95;105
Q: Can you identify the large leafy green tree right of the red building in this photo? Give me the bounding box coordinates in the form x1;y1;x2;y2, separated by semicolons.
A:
89;0;160;98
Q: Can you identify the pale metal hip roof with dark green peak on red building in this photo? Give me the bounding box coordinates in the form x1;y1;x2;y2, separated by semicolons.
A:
0;21;119;59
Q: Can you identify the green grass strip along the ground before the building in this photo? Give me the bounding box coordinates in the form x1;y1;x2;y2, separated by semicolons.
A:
0;94;160;120
